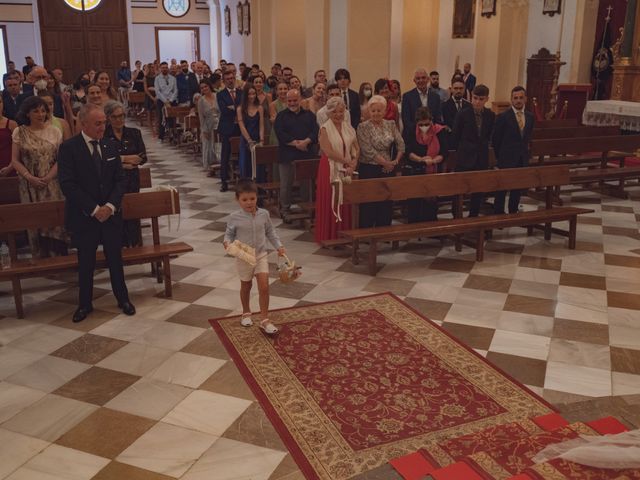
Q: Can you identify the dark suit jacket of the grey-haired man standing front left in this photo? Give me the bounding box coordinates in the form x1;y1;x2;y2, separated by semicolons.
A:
58;134;127;234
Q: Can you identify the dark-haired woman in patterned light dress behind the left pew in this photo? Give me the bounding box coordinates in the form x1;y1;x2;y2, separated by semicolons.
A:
11;97;67;257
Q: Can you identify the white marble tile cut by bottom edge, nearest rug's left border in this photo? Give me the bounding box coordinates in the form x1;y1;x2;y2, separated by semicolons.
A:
182;438;286;480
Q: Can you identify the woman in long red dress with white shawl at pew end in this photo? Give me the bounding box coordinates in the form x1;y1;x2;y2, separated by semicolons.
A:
314;97;360;244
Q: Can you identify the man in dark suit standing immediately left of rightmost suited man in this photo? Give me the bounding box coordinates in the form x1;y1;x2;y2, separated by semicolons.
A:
452;85;496;217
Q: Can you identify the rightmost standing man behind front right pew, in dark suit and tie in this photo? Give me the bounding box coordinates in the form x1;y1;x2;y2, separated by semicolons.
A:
492;85;535;214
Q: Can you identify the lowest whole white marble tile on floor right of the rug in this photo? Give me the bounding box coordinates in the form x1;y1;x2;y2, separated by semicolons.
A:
544;362;611;397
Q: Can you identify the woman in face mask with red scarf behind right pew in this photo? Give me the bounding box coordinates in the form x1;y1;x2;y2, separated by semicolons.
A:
402;107;448;223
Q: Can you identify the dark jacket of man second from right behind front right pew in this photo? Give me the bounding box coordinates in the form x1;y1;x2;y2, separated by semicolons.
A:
453;108;496;171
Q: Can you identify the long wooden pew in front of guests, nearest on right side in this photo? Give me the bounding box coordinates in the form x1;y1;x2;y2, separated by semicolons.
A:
340;165;593;275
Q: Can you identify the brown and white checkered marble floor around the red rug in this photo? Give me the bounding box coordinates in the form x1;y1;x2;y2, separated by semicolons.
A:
0;127;640;480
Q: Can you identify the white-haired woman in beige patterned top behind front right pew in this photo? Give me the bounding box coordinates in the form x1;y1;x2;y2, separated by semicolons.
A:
358;95;405;228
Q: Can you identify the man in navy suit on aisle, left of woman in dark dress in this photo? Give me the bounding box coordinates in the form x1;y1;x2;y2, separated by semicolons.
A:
216;69;242;192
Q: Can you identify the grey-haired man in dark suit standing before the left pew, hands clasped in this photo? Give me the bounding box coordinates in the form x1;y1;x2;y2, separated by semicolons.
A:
58;104;136;323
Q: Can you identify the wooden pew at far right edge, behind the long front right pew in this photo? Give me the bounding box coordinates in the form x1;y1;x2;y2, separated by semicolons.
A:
530;135;640;198
